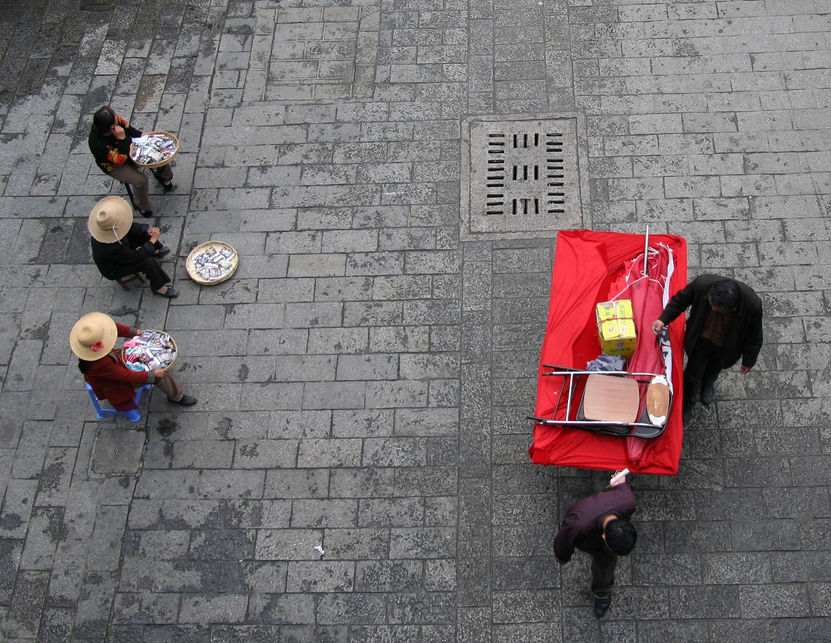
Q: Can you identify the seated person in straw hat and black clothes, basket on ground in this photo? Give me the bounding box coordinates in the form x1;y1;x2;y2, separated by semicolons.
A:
87;196;179;299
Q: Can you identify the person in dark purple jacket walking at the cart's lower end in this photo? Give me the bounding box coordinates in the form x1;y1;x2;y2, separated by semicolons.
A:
554;481;638;618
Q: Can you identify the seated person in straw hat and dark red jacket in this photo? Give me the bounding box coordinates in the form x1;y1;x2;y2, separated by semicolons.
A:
69;313;196;411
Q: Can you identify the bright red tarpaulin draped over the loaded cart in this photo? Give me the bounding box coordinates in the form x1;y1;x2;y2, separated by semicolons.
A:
529;230;687;474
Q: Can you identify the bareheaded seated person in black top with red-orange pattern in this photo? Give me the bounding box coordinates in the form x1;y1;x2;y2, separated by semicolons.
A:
88;106;175;217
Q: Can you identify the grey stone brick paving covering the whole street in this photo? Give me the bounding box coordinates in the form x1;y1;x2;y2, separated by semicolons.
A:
0;0;831;643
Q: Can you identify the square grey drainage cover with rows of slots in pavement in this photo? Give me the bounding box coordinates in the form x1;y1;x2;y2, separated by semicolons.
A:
467;118;582;234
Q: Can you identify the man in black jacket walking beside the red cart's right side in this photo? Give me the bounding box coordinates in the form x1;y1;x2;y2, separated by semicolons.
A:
652;275;762;424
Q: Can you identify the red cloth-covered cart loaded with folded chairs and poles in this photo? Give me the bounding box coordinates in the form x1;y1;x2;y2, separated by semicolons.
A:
529;230;687;474
